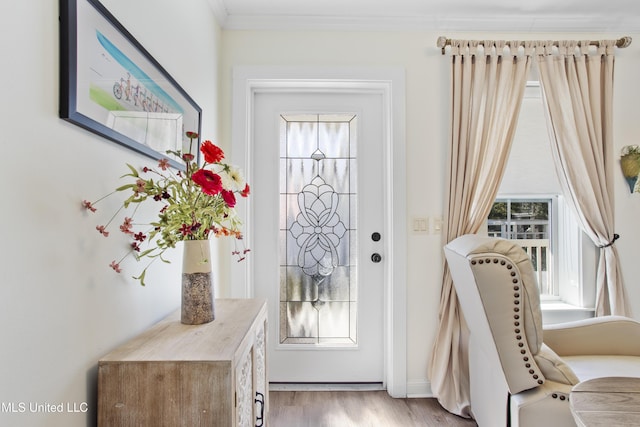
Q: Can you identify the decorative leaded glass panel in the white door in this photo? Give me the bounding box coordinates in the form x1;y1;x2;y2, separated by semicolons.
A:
279;114;358;345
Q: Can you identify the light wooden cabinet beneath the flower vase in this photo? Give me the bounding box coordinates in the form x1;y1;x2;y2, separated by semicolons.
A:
98;299;269;427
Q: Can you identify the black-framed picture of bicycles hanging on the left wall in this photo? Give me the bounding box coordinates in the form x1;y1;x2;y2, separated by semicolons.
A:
59;0;202;169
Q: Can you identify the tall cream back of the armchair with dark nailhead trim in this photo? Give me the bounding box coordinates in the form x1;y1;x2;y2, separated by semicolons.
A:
444;235;545;394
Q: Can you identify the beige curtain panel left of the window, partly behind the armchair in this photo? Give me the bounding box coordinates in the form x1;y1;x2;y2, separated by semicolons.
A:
429;40;533;418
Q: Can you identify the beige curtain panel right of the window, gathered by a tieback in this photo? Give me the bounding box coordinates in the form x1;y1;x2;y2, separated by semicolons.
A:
535;40;630;316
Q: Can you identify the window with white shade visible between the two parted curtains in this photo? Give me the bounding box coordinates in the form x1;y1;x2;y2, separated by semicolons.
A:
487;81;597;320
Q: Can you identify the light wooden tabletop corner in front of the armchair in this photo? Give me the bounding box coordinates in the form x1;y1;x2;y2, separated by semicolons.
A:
569;377;640;427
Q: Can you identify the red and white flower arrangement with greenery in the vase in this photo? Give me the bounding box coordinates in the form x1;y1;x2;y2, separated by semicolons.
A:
82;132;250;286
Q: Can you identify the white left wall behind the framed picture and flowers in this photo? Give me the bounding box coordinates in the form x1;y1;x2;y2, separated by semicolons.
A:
0;0;220;427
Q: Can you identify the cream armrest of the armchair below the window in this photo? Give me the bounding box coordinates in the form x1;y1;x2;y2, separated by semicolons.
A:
543;316;640;356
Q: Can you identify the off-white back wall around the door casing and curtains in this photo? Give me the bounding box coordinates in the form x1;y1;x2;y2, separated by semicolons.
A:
221;31;640;394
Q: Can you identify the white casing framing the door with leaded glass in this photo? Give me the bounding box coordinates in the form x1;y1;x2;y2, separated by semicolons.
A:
231;67;407;397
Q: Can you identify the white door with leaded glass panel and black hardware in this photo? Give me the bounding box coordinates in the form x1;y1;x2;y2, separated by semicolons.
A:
251;90;391;383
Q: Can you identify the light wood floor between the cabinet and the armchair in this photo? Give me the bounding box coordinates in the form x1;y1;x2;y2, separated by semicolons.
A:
269;391;476;427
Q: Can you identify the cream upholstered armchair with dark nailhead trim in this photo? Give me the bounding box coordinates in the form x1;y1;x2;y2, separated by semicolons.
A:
445;235;640;427
